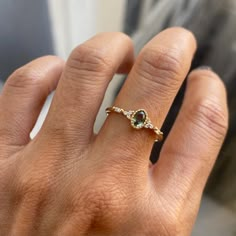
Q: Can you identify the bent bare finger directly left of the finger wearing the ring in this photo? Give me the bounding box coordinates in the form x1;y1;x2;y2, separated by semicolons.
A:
42;33;134;145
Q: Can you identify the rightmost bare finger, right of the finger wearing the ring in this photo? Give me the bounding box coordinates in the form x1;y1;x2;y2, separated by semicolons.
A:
154;69;228;212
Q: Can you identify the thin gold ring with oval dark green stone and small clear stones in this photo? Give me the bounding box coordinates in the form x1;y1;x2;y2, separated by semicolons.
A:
106;106;163;142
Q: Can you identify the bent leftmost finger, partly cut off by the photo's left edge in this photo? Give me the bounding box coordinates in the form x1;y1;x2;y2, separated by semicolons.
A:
0;56;63;146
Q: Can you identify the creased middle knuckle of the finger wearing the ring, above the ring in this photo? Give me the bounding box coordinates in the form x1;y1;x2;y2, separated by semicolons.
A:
136;48;183;94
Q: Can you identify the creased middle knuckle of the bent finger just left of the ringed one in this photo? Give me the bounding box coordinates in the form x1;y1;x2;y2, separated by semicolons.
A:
68;44;112;77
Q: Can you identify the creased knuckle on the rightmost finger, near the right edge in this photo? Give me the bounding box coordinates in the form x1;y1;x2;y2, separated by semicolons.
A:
190;99;228;140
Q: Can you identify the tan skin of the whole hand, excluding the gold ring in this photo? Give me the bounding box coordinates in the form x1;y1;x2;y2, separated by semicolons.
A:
0;28;228;236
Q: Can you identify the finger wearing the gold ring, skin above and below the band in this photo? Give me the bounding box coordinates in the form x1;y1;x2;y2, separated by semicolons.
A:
98;28;196;168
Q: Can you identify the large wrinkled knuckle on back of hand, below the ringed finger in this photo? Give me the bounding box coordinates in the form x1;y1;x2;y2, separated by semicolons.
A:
72;177;127;225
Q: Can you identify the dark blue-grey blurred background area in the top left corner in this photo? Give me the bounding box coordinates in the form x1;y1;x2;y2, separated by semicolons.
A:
0;0;53;80
